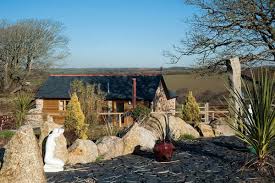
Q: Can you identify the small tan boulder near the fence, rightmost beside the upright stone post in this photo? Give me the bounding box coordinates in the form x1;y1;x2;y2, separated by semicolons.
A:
209;118;235;136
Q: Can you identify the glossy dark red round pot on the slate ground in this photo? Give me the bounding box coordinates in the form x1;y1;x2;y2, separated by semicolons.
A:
153;142;175;161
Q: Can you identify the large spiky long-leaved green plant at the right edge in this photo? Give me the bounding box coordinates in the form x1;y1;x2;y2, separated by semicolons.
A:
228;69;275;168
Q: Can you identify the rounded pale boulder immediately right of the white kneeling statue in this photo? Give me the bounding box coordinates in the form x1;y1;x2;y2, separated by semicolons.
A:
67;139;98;164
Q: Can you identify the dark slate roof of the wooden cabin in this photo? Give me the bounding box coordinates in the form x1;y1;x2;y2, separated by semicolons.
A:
36;75;176;101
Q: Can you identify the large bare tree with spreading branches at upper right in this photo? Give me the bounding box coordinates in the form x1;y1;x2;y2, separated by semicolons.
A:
166;0;275;69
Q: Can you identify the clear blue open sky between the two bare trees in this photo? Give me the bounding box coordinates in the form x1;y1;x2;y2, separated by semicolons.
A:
0;0;198;68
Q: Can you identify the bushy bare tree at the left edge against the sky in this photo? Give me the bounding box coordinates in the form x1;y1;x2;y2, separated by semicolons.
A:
0;19;68;92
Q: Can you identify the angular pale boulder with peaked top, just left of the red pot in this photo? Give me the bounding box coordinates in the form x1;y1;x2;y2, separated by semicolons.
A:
122;123;158;154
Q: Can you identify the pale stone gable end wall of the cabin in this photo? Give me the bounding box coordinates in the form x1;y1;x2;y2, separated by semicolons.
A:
153;83;176;113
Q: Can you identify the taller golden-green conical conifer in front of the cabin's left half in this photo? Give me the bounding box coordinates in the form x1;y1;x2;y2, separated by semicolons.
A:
64;93;88;141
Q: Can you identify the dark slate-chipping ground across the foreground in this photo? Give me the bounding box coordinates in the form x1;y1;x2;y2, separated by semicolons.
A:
47;137;275;183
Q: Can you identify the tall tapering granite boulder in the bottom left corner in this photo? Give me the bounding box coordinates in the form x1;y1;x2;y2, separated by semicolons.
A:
0;125;46;183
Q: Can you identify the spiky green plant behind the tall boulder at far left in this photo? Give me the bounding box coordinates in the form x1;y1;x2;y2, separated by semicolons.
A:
13;92;33;128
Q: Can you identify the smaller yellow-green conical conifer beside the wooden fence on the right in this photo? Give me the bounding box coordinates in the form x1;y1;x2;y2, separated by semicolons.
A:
181;91;200;124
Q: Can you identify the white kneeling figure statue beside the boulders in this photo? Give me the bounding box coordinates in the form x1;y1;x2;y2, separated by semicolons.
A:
44;128;64;172
